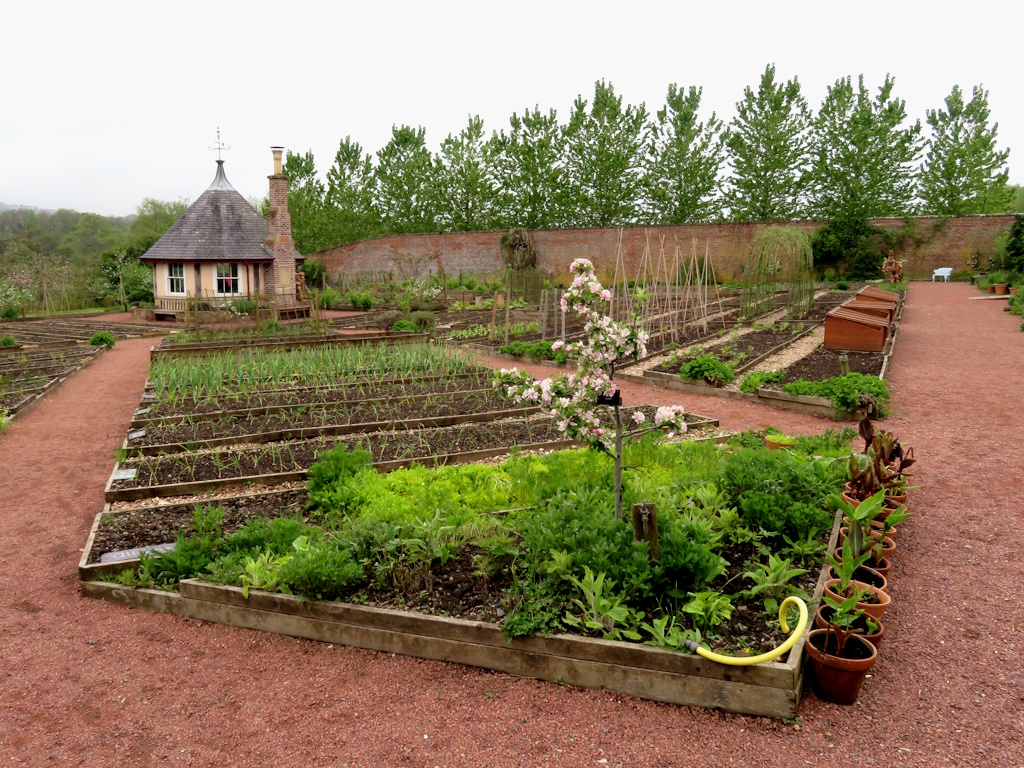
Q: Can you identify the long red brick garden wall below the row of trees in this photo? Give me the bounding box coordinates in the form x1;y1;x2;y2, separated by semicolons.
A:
308;214;1014;281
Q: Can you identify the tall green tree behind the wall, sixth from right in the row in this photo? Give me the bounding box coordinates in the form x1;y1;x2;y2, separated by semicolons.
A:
487;106;565;229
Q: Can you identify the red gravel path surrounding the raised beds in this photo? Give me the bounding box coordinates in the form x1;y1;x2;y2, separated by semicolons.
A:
0;283;1024;767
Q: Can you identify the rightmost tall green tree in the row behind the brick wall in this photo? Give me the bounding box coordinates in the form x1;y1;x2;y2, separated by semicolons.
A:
921;85;1014;216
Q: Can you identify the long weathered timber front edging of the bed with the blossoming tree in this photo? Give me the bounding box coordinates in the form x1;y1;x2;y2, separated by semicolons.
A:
82;581;804;717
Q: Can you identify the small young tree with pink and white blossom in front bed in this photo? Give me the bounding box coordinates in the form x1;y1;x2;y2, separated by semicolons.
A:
499;259;686;518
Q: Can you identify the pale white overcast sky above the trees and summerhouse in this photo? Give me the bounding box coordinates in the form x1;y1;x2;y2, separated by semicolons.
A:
0;0;1024;215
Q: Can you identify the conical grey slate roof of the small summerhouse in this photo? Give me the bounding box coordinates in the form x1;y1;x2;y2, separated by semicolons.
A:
141;160;273;262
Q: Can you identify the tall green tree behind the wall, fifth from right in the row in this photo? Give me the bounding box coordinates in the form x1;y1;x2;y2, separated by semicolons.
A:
565;80;650;226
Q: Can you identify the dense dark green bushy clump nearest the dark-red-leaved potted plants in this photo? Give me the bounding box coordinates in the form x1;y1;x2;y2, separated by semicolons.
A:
719;446;840;538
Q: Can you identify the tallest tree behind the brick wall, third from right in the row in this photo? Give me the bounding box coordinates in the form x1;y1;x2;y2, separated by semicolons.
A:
725;65;811;221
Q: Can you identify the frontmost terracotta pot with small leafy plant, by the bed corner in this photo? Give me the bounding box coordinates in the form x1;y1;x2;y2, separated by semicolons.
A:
806;596;879;703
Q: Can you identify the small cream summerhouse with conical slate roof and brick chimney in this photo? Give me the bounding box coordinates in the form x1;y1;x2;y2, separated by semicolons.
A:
141;146;308;318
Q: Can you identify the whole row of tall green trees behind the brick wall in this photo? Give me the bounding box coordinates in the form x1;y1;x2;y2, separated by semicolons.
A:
286;66;1014;253
